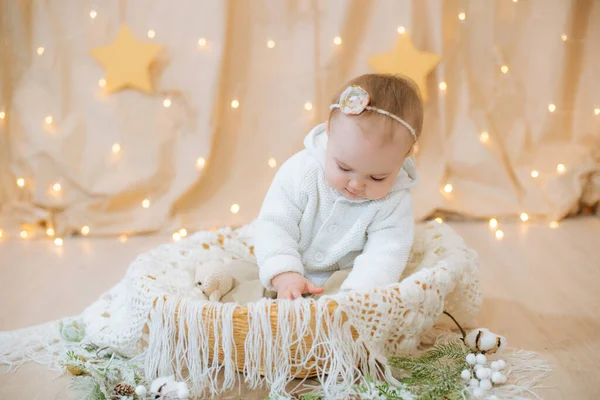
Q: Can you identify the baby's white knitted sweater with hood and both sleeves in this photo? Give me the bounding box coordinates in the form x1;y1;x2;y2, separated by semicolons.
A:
255;125;417;290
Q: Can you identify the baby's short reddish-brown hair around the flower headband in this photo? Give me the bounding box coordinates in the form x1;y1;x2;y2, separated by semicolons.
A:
329;74;423;138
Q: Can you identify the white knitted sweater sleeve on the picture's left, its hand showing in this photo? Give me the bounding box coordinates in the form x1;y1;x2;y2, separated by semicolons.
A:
255;151;309;289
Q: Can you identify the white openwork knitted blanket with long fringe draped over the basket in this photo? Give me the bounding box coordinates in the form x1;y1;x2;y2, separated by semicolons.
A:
0;222;482;395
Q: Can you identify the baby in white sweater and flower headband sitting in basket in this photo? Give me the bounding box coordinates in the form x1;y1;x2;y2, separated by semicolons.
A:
255;74;423;299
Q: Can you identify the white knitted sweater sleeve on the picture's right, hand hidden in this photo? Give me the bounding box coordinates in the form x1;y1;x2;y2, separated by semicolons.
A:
342;190;415;290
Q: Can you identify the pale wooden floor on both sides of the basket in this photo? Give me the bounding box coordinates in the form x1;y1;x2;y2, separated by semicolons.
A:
0;217;600;400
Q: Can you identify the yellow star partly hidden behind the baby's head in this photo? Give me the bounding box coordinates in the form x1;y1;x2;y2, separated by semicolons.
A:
369;35;441;101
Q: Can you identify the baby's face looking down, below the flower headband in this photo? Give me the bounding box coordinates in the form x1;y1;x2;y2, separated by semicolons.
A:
325;114;413;200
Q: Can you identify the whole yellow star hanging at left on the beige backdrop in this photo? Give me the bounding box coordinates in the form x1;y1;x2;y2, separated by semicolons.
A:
90;25;162;93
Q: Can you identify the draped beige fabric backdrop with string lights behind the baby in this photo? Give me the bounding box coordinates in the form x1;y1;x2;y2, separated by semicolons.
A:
0;0;600;236
